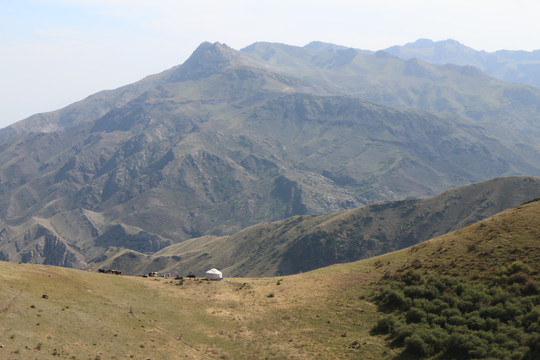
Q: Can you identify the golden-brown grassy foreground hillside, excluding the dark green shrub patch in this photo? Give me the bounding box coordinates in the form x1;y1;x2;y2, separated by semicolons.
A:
0;201;540;359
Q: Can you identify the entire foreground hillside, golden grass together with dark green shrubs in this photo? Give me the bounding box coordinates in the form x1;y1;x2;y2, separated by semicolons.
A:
0;193;540;359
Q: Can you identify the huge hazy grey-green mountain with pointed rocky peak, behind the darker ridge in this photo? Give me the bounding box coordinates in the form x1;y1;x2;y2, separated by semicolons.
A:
0;38;540;274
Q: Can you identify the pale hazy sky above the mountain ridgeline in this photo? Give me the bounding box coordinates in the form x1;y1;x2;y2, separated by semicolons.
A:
0;0;540;127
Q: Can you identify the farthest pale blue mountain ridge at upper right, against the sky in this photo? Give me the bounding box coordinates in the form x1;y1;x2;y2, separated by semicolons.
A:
384;39;540;88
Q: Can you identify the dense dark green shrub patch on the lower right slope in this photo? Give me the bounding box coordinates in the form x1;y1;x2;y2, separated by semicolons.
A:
371;261;540;359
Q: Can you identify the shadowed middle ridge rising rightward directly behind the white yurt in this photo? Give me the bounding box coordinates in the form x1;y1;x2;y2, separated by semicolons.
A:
93;177;540;276
